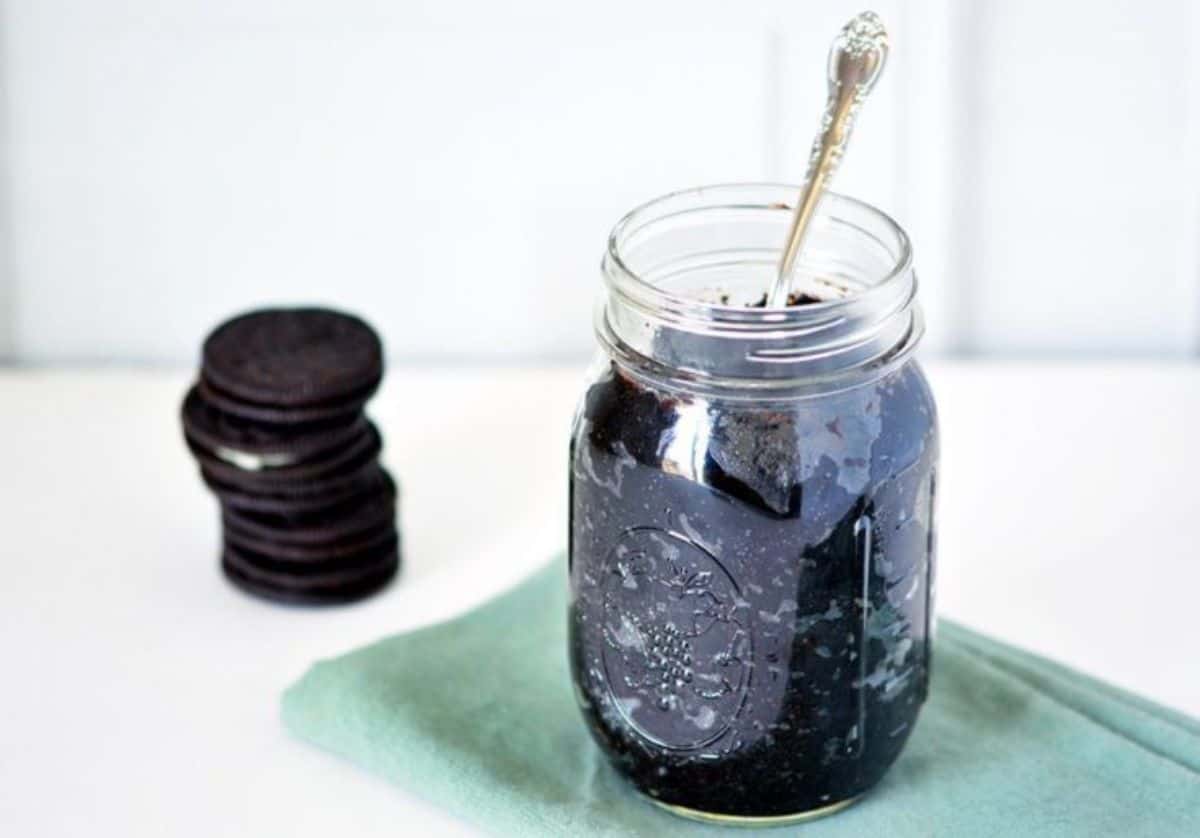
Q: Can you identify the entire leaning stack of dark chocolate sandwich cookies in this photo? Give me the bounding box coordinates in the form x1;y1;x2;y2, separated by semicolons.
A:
182;309;400;603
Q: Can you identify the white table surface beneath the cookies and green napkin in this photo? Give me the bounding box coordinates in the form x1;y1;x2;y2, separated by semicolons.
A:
0;363;1200;838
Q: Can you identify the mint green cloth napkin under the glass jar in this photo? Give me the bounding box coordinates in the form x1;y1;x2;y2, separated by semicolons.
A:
283;562;1200;838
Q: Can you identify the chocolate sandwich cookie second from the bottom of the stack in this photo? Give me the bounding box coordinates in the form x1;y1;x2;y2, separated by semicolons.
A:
222;469;396;546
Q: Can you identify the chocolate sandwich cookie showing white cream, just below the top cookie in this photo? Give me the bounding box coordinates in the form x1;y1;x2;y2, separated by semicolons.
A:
180;387;367;471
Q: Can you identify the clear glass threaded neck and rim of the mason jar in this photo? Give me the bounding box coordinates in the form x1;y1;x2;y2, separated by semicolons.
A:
596;184;923;391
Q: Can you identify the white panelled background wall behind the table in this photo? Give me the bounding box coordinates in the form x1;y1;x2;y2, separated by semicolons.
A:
0;0;1200;363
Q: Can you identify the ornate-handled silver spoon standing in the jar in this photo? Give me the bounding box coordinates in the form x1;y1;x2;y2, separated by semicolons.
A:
767;12;888;309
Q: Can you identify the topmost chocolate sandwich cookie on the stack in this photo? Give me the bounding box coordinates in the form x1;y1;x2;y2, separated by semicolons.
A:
203;309;383;408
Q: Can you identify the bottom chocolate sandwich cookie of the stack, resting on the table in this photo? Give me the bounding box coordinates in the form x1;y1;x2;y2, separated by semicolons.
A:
221;538;400;605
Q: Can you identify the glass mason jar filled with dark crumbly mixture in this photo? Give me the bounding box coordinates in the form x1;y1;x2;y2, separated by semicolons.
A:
570;185;937;822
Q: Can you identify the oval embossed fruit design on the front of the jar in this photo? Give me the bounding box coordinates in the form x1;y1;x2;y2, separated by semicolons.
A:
601;527;752;750
